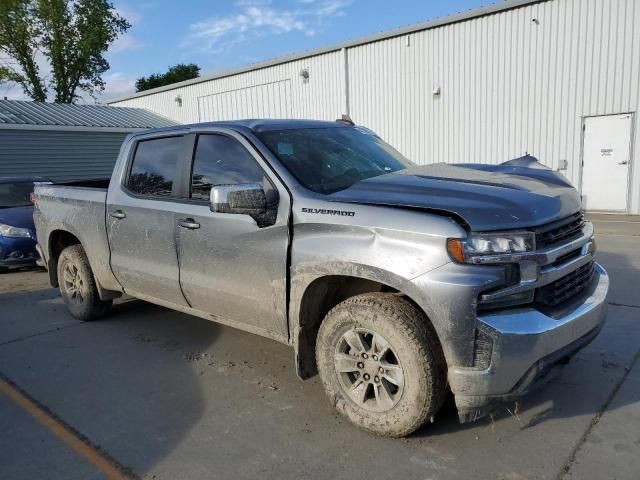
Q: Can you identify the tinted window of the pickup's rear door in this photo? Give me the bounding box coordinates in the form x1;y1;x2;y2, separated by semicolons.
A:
127;137;182;197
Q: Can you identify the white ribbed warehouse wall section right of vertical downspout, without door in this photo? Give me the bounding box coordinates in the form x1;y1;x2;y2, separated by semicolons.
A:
349;0;640;212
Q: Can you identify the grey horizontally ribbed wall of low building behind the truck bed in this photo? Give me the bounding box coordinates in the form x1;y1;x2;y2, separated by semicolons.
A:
0;129;127;182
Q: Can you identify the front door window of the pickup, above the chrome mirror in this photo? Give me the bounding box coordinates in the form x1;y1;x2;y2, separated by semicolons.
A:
191;134;264;201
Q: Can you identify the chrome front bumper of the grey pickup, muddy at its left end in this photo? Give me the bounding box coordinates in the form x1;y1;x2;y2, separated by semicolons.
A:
449;264;609;421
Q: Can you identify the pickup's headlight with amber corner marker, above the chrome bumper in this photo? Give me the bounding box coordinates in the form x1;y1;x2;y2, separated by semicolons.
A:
447;232;536;263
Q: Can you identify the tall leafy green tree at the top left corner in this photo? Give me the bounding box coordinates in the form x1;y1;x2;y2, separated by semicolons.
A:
0;0;131;103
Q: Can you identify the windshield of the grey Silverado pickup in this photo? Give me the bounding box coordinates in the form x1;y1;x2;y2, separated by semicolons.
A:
258;127;413;194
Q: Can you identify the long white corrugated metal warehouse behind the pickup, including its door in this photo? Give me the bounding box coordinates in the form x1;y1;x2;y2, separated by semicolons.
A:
111;0;640;214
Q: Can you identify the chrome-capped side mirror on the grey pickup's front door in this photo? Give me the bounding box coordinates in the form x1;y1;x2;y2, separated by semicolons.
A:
210;183;267;216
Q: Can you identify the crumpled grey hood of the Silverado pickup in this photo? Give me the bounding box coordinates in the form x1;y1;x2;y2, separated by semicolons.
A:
328;163;581;231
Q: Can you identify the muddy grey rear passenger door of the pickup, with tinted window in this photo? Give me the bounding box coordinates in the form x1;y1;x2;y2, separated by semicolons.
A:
107;135;188;306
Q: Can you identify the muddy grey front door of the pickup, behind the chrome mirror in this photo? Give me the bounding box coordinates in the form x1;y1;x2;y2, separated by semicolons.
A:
172;130;290;339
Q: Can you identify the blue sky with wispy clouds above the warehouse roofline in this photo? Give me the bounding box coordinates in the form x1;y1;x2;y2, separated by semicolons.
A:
0;0;491;101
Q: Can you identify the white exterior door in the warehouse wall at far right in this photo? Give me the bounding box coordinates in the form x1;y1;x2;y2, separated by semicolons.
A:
582;114;633;212
